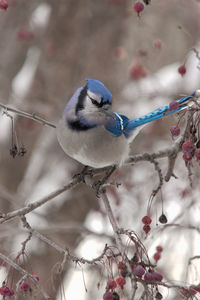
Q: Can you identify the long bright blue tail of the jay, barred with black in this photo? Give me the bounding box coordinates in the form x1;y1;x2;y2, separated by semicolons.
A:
125;92;195;135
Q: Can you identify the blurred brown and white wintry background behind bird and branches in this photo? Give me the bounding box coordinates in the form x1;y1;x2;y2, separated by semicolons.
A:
0;0;200;300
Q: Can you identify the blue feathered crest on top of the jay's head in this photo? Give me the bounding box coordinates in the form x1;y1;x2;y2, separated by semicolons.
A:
86;79;112;104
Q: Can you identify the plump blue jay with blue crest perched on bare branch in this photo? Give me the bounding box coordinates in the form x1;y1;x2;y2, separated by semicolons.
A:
56;79;195;168
